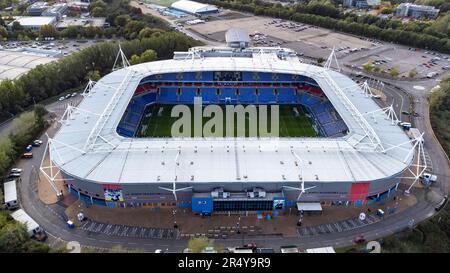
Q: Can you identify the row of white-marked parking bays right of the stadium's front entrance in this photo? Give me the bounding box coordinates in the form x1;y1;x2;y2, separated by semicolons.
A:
297;213;382;236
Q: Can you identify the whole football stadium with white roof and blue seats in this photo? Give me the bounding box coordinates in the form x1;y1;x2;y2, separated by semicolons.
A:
48;29;415;212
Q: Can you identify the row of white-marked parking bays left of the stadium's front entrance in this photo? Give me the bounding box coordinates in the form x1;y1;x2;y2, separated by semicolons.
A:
80;220;180;240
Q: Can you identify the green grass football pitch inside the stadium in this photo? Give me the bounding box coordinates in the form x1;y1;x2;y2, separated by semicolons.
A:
136;104;318;137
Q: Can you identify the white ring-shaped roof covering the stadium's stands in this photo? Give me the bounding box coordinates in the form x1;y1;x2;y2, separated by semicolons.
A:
50;45;413;184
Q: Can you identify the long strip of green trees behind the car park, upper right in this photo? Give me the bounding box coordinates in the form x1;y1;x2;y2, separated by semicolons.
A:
199;0;450;53
